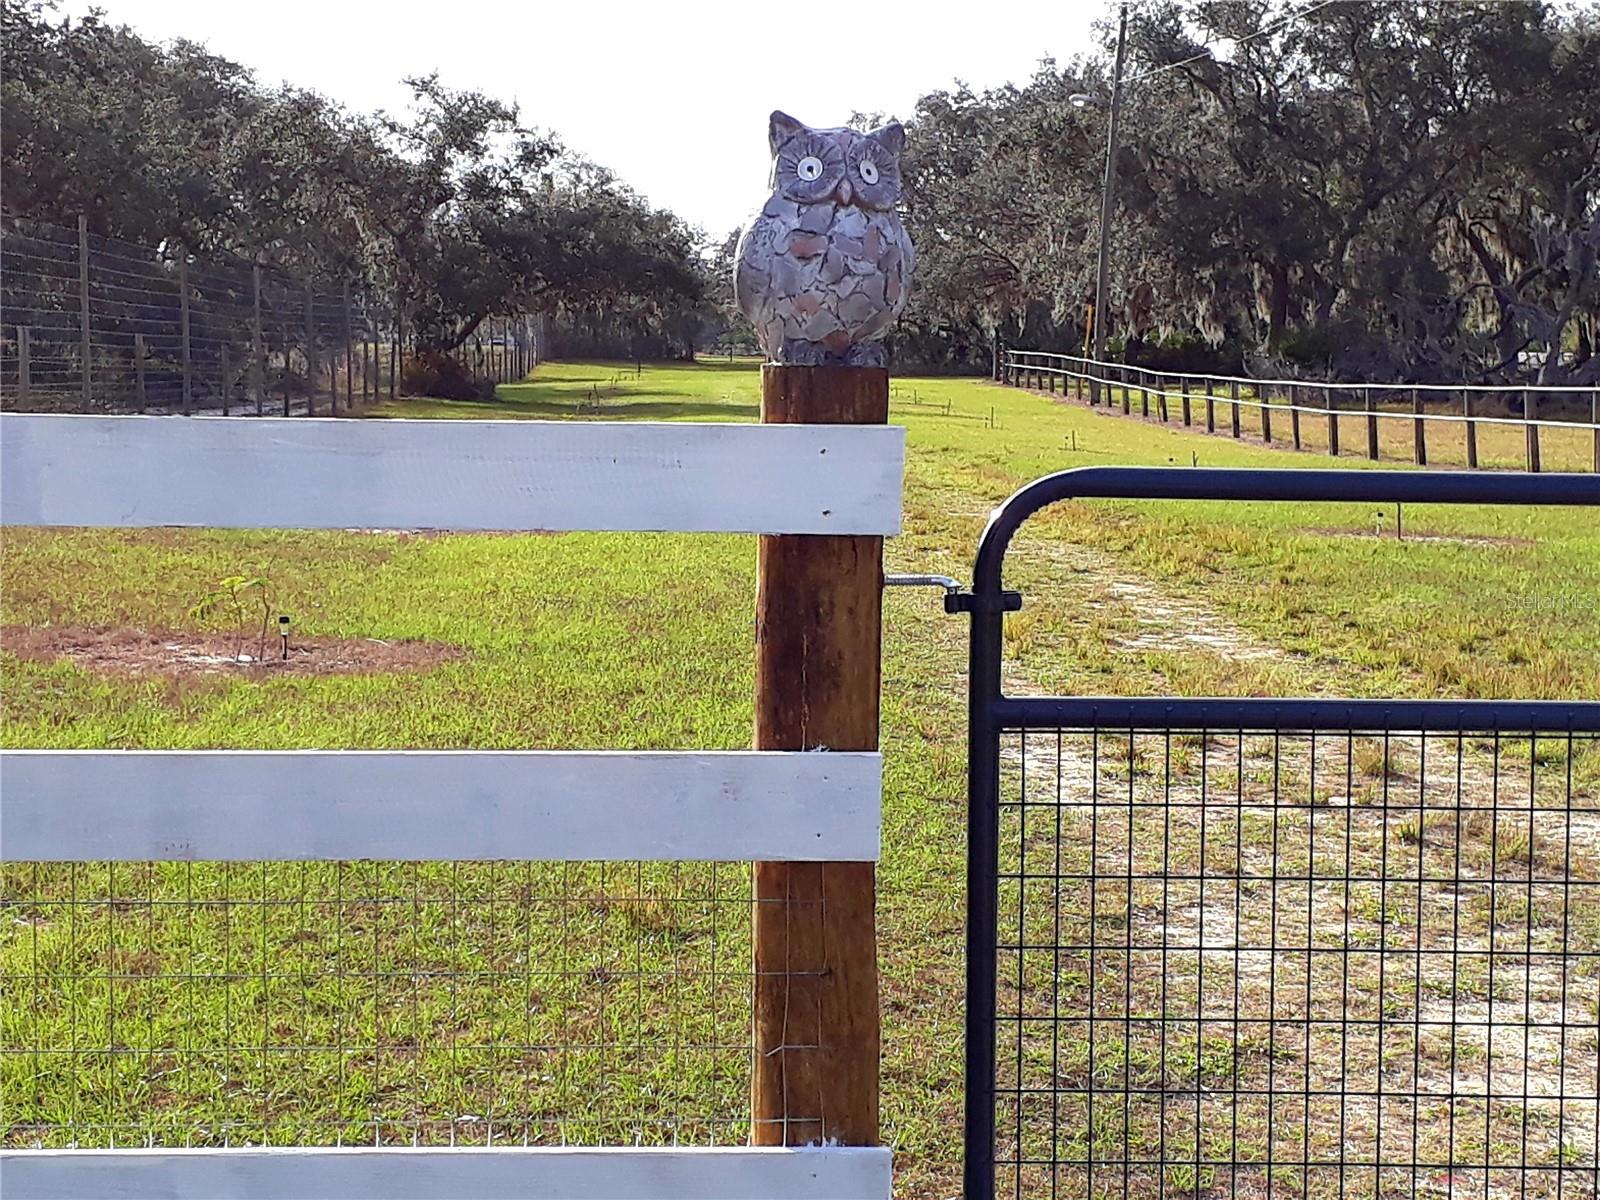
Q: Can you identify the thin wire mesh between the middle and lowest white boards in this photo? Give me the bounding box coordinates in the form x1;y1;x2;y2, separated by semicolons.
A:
0;862;752;1147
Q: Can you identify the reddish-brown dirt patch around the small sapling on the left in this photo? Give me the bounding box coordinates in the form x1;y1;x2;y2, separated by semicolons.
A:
0;626;466;677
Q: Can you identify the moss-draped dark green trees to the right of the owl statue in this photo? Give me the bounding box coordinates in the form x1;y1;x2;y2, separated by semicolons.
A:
902;0;1600;382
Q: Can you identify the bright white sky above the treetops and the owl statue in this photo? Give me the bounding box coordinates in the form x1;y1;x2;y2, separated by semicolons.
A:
61;0;1104;235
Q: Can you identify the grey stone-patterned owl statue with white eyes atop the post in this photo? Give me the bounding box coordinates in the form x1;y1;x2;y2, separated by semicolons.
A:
733;112;915;366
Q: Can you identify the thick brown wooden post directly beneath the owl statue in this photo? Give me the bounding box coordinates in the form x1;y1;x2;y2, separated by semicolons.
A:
750;363;890;1146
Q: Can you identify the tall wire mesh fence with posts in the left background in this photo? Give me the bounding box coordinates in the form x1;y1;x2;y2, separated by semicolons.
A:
0;221;533;416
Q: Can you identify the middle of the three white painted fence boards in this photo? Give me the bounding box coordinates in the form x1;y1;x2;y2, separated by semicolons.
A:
0;750;883;862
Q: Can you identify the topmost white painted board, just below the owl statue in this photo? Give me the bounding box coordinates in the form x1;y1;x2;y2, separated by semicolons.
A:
0;413;906;534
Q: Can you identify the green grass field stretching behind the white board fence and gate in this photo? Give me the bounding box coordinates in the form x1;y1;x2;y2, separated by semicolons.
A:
0;363;1600;1197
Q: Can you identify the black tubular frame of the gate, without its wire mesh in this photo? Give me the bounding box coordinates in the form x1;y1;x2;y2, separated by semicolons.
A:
946;467;1600;1200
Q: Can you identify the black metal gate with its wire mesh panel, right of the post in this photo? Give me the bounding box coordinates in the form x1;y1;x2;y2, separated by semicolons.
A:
949;467;1600;1200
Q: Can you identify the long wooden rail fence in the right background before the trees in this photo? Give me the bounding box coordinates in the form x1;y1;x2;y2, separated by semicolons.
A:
1000;350;1600;472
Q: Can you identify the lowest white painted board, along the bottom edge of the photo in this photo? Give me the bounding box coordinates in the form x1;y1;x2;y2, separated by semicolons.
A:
0;1147;891;1200
